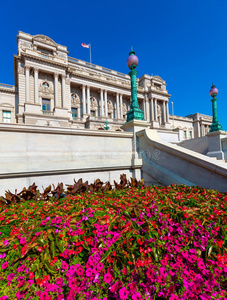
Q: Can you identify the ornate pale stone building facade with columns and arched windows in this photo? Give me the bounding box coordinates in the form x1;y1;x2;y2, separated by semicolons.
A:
0;32;212;140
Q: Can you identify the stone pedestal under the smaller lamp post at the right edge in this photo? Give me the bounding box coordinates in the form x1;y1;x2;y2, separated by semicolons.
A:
207;131;226;160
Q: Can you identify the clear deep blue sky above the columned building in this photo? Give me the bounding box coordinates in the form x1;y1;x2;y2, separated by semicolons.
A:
0;0;227;130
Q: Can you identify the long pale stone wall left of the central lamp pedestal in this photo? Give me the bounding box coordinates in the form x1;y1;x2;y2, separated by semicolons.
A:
0;124;132;195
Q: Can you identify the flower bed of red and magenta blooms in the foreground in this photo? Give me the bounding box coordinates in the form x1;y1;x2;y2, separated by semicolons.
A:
0;185;227;300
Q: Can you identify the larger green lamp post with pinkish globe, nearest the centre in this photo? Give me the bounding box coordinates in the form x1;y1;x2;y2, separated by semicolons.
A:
127;48;144;122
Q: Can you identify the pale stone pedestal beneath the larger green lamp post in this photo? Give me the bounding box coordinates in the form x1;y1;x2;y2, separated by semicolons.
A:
121;119;149;180
